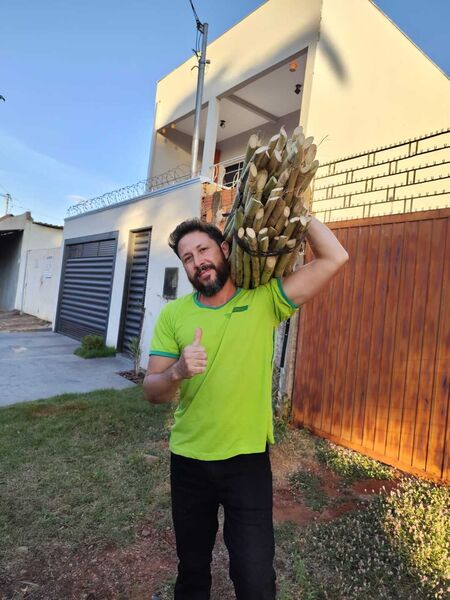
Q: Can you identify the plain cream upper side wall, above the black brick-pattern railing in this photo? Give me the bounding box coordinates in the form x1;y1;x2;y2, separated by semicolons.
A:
307;0;450;162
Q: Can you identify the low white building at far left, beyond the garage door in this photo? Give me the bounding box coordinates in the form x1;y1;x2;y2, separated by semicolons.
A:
0;212;63;321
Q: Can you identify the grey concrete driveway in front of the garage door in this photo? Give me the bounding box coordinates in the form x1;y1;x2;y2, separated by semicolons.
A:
0;331;134;406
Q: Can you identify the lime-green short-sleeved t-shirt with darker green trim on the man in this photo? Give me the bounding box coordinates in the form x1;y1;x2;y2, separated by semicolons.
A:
150;279;298;460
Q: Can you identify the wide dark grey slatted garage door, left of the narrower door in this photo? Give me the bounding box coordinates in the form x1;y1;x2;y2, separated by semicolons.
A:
56;232;117;340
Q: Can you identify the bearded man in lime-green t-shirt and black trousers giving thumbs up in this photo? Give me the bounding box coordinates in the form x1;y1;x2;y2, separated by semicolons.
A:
144;213;348;600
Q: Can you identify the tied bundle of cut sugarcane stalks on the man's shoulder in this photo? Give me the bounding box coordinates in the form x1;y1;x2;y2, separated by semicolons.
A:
224;127;319;289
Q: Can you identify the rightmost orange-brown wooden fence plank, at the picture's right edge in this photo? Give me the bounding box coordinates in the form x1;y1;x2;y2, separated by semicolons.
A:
425;219;450;477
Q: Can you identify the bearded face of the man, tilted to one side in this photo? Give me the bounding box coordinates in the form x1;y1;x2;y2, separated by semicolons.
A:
178;231;229;296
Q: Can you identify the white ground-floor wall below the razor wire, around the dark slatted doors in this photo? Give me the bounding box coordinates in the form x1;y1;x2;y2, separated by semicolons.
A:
60;179;202;367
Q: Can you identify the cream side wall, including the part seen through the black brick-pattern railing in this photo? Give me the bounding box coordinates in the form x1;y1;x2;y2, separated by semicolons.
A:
307;0;450;220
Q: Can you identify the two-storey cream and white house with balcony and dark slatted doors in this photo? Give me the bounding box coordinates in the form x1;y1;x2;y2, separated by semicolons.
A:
55;0;450;366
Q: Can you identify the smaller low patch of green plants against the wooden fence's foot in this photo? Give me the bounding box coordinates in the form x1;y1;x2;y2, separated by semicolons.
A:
316;440;395;484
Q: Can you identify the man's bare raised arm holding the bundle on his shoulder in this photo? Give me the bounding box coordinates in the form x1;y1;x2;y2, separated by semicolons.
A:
282;217;348;305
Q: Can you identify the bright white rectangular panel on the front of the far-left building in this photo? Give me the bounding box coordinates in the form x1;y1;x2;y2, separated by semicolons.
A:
21;247;61;321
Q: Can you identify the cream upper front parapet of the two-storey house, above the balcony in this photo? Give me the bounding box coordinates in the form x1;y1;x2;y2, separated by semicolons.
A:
149;0;322;175
